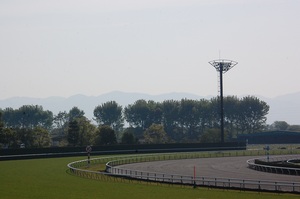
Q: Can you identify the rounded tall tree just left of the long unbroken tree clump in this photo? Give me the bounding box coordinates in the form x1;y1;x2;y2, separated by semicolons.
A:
94;101;124;132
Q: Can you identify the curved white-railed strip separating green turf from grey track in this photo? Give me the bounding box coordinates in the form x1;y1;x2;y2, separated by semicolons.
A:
68;151;300;193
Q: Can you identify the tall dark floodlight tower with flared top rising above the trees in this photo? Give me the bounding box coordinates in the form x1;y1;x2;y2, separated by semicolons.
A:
208;59;237;143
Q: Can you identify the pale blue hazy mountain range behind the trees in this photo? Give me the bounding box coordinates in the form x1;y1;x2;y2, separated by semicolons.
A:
0;91;300;125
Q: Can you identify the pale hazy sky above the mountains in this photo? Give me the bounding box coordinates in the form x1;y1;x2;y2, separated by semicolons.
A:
0;0;300;99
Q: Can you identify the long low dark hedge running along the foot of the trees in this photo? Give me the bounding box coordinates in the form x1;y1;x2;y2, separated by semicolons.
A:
0;142;246;159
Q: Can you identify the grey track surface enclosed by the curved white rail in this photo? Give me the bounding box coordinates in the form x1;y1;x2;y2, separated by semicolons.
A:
118;156;300;182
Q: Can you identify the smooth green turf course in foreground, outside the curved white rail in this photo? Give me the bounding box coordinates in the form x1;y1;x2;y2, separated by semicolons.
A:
0;157;299;199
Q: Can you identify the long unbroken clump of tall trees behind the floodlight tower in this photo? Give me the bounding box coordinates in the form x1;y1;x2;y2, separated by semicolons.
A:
124;96;269;142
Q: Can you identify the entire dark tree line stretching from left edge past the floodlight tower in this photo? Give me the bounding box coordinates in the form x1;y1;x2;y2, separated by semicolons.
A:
0;96;290;148
